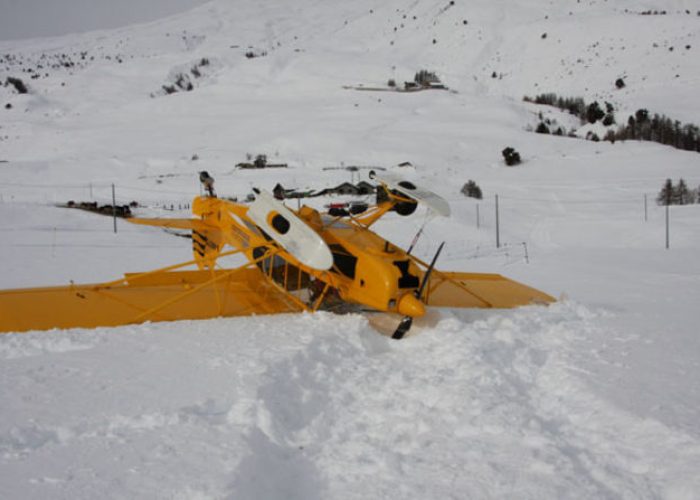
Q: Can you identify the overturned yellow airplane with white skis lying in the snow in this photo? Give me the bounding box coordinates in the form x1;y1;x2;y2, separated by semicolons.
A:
0;172;554;339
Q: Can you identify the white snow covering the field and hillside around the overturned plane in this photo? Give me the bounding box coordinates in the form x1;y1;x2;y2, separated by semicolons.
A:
0;0;700;500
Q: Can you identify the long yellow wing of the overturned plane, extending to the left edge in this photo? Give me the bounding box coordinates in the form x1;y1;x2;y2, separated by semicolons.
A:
0;268;301;332
